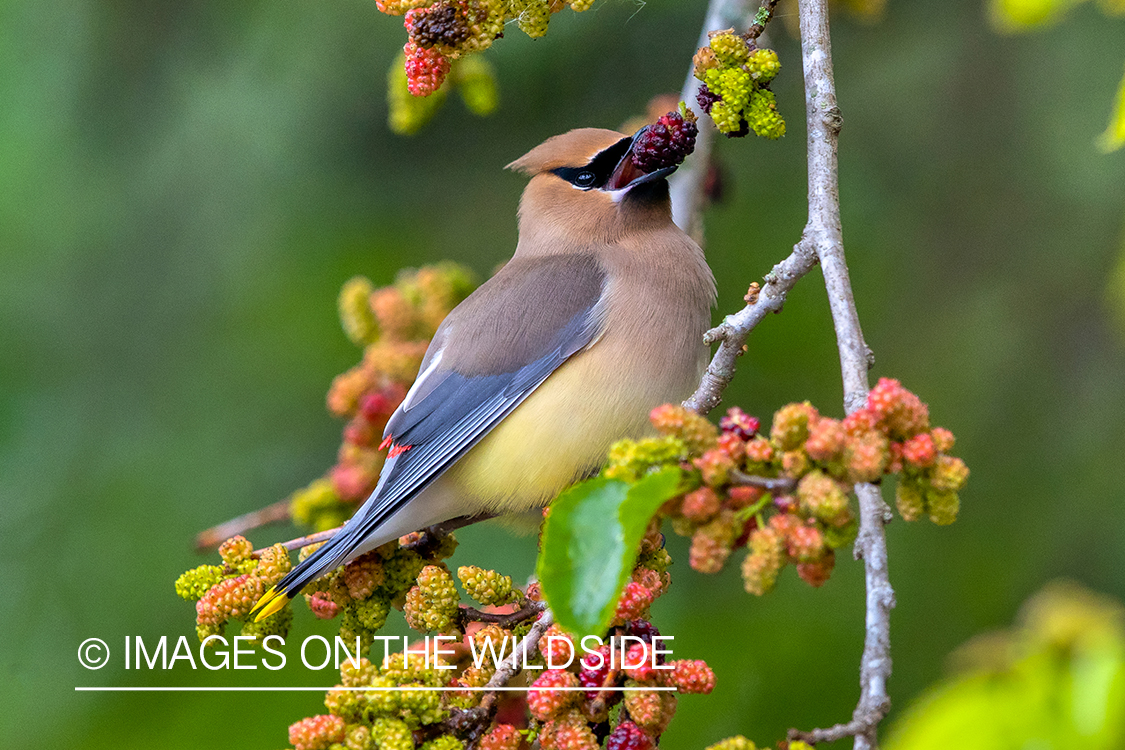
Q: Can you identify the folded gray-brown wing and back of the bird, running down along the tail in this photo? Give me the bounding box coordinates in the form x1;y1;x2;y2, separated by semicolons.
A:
265;255;605;596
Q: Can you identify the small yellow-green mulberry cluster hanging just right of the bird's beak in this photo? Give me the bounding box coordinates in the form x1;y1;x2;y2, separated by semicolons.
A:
694;29;785;138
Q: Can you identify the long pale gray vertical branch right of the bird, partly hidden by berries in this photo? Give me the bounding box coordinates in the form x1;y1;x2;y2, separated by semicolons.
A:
797;0;894;750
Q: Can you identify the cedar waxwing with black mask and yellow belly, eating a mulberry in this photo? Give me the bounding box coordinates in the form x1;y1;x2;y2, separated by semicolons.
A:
255;128;716;620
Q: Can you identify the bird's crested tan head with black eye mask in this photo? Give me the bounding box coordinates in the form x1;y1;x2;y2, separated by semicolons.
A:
507;128;675;250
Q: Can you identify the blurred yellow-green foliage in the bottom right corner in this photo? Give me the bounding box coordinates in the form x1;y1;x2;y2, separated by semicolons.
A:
887;581;1125;750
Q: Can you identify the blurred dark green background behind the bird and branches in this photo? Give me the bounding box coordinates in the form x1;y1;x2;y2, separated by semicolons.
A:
0;0;1125;749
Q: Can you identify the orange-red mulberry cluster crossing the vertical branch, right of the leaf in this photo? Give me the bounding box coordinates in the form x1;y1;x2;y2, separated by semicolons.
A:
634;382;969;595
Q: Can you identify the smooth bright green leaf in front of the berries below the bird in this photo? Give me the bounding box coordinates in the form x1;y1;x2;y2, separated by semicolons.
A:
538;467;683;634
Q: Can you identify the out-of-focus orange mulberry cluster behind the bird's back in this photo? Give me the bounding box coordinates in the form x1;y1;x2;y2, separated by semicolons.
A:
290;263;476;530
